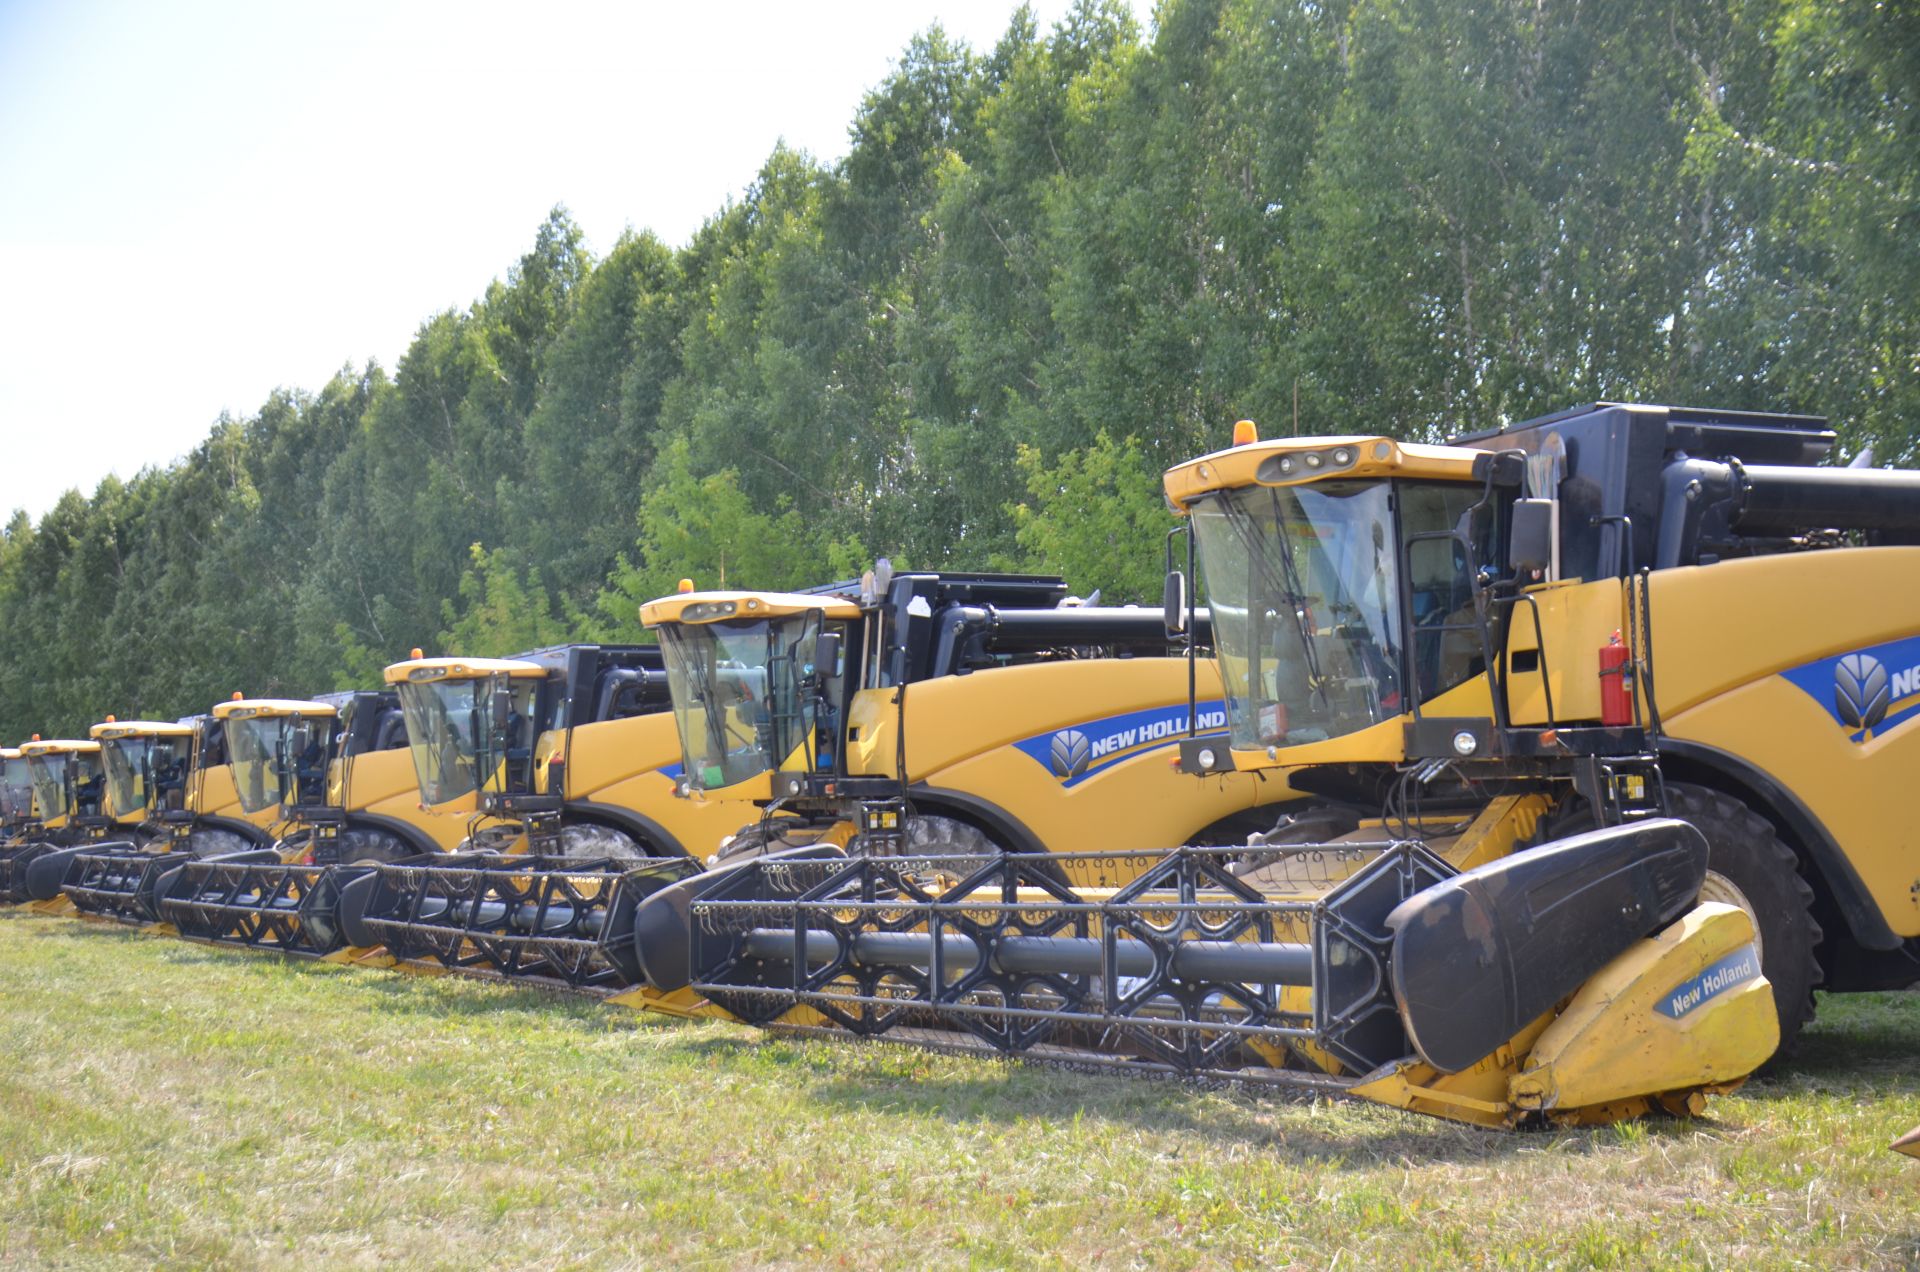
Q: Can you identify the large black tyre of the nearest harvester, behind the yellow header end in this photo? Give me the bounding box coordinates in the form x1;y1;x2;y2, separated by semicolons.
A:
1667;782;1820;1053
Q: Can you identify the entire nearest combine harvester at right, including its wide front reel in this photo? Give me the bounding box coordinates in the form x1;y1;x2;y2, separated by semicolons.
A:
637;404;1920;1124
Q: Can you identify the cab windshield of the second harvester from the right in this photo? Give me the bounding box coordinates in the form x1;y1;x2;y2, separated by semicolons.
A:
660;613;820;790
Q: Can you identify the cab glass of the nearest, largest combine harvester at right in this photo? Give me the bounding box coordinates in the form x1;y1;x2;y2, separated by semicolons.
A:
1194;480;1480;749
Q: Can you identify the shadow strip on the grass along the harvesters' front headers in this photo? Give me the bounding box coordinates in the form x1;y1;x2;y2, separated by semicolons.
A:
22;911;1920;1166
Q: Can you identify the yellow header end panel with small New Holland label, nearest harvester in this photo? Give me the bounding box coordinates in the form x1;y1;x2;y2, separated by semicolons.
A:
1511;901;1780;1113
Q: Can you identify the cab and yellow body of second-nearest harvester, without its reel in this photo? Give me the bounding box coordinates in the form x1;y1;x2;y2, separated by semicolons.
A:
641;563;1290;882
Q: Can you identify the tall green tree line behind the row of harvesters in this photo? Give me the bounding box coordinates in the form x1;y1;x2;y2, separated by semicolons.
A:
0;0;1920;742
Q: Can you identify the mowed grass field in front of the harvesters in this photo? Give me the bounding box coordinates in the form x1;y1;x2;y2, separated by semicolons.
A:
0;913;1920;1268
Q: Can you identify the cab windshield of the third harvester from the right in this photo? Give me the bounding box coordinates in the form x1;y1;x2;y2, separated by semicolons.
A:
396;678;538;805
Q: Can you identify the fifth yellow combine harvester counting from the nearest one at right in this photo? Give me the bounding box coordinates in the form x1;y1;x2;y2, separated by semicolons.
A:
54;715;276;922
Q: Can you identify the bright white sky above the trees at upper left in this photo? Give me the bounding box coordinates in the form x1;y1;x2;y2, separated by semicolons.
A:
0;0;1146;517
